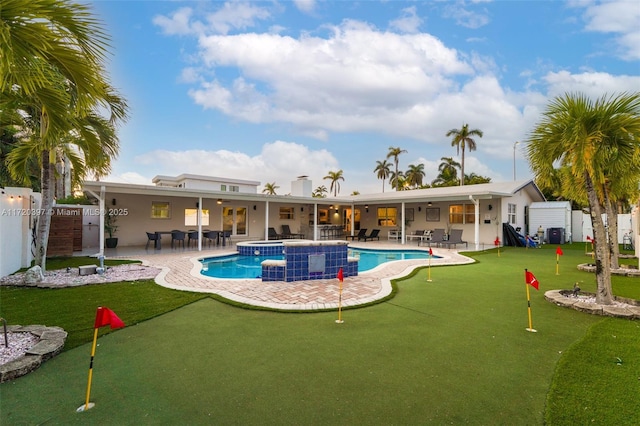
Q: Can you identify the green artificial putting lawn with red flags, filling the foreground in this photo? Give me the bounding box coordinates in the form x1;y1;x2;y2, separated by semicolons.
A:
0;244;640;425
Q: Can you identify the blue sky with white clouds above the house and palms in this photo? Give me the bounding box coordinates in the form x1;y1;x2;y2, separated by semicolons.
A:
91;0;640;195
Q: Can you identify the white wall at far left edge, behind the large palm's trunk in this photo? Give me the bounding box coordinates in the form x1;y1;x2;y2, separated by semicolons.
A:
0;187;40;277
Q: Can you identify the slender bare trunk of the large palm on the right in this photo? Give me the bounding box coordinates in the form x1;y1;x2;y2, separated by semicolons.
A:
584;172;613;305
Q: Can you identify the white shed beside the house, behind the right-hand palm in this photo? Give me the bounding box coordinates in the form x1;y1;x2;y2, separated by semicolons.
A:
529;201;571;244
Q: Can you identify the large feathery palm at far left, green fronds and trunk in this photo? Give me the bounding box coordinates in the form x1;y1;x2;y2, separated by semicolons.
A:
0;0;127;270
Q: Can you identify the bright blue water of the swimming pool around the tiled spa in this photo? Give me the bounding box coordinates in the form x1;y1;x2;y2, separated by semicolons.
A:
200;249;437;278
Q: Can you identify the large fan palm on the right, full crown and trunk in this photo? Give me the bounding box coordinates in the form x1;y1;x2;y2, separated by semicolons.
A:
527;92;640;304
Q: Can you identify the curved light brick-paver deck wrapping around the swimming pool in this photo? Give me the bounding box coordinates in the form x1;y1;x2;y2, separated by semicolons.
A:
137;244;474;311
